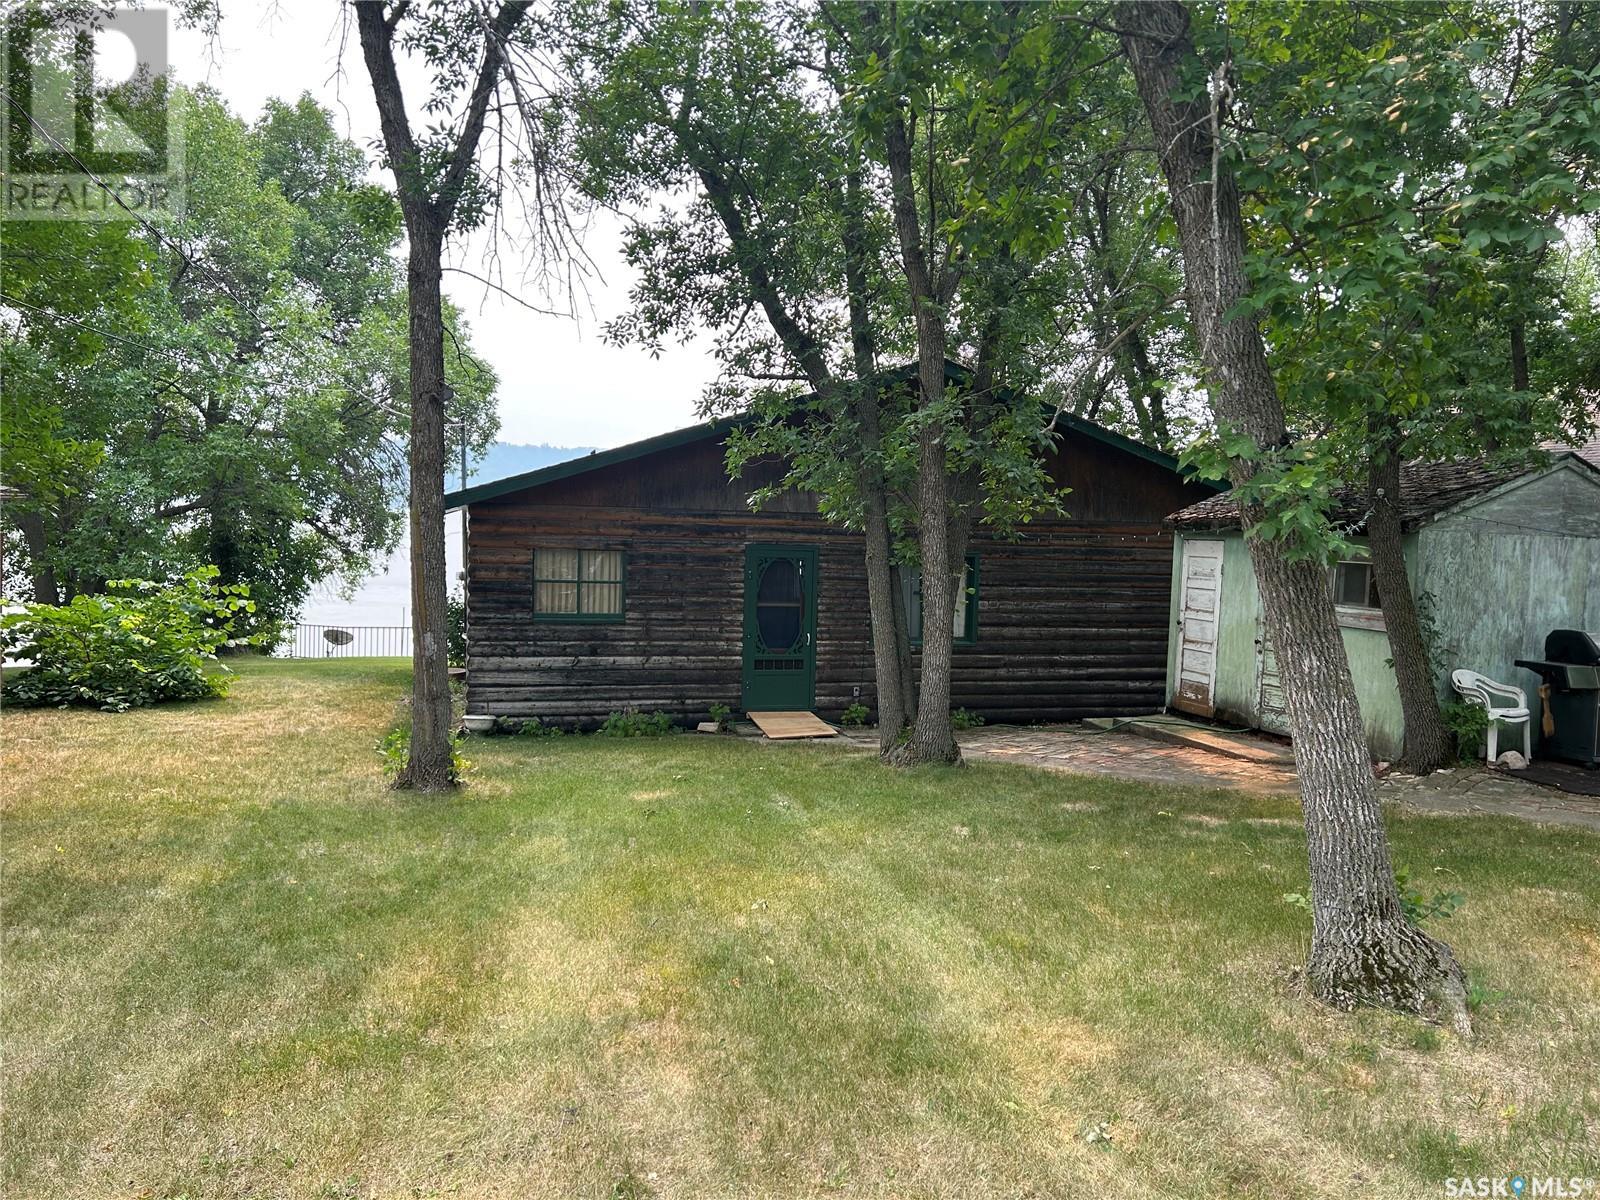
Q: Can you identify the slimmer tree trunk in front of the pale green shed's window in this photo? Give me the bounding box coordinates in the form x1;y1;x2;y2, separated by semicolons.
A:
1366;430;1454;774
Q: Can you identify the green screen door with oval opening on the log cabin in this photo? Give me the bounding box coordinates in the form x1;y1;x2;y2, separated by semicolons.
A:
744;546;816;712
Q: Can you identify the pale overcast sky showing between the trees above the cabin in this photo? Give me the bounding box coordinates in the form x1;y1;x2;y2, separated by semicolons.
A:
171;0;717;448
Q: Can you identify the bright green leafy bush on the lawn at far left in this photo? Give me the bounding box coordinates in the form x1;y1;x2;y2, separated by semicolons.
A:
0;566;256;712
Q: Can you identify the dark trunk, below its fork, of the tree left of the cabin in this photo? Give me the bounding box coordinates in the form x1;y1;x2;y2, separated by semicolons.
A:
397;219;456;790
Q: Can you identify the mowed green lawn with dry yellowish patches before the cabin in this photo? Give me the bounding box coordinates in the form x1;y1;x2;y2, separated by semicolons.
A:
0;661;1600;1200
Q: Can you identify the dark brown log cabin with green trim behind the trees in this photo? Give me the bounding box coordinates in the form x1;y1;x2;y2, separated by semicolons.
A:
446;400;1216;728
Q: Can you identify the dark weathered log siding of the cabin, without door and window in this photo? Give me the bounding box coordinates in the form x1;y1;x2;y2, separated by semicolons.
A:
467;425;1202;726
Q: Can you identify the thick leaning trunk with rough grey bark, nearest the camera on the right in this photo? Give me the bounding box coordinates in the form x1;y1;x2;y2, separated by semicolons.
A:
1117;0;1469;1032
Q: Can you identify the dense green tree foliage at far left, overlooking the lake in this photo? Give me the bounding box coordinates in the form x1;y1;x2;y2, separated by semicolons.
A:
0;91;498;640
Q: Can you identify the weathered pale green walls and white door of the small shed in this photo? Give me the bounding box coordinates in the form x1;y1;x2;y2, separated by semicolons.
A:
1166;443;1600;758
